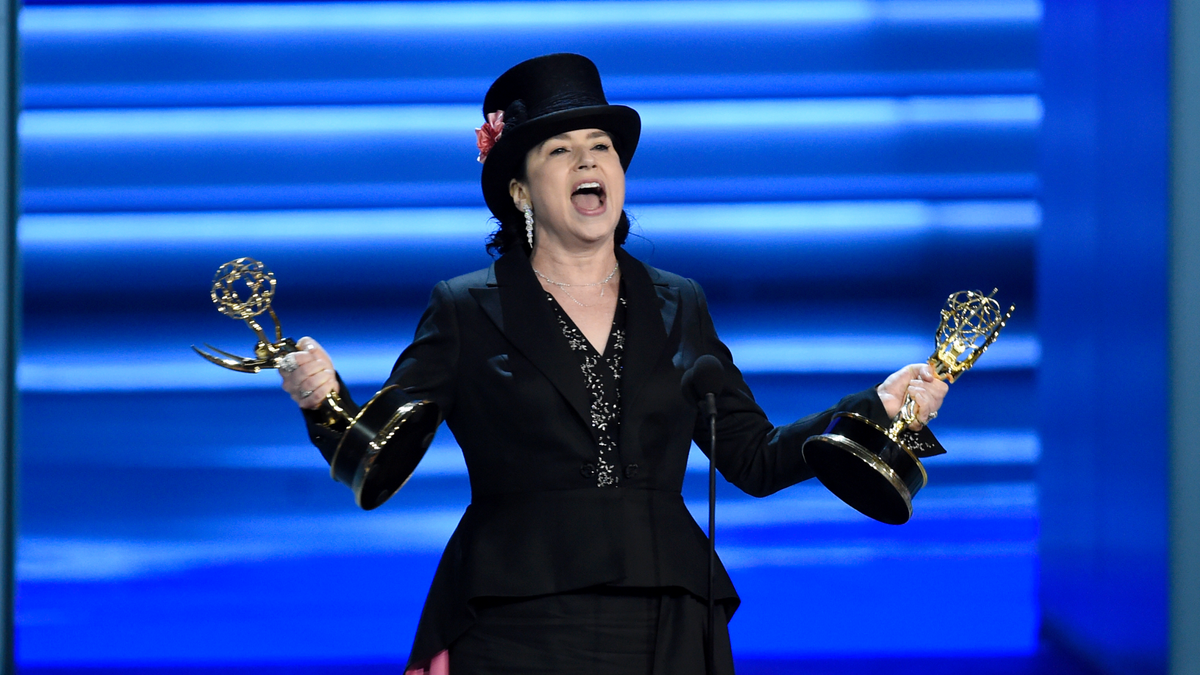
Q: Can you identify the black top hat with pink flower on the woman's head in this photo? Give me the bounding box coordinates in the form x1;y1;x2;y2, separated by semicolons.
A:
481;54;642;222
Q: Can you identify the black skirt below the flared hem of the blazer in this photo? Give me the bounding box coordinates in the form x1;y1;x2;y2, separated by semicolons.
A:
449;587;733;675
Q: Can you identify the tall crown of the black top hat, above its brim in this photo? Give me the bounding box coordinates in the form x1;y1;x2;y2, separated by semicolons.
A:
484;54;608;121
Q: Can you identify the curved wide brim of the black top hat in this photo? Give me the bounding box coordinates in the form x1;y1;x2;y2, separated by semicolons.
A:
480;106;642;222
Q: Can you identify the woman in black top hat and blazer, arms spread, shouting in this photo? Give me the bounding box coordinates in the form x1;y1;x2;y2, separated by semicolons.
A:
283;54;947;675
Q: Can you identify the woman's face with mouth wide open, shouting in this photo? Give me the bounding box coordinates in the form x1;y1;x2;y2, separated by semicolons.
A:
509;129;625;249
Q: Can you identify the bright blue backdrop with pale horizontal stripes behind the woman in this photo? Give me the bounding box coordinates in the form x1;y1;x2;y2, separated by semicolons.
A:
17;0;1042;668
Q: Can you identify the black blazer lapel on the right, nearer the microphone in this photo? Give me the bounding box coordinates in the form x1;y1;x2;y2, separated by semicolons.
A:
617;249;679;410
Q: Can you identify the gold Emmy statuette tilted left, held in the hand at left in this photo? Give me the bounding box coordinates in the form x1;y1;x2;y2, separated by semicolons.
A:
192;258;442;510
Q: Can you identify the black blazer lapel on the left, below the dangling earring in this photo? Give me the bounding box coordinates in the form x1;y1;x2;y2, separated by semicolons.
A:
470;250;595;430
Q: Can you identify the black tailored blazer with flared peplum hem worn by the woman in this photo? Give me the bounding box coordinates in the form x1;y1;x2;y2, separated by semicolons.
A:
310;243;888;667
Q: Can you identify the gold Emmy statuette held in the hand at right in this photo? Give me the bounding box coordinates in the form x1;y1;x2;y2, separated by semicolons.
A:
802;289;1016;525
